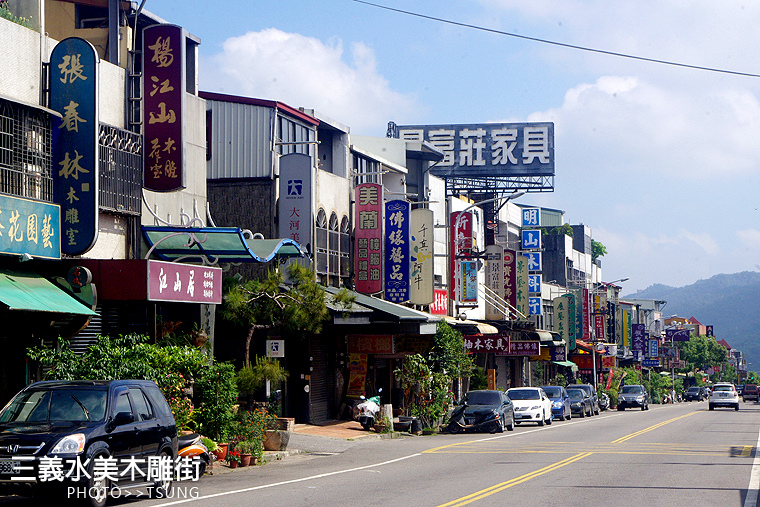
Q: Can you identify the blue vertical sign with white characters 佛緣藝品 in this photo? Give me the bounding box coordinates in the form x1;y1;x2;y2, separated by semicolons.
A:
385;200;410;303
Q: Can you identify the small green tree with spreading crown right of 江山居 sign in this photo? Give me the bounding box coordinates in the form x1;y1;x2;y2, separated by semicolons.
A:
221;263;329;367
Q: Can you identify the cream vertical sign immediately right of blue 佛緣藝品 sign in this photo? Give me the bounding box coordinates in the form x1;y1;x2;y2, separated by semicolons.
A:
409;208;435;305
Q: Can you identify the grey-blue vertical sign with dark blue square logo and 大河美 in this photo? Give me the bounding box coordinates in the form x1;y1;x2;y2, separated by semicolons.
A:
278;153;314;250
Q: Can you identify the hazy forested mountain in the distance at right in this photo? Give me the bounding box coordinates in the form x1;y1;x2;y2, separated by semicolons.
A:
621;271;760;371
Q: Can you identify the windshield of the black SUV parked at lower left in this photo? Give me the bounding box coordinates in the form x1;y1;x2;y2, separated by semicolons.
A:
0;388;107;424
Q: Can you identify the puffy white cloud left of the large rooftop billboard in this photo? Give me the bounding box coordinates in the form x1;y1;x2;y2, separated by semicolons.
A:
202;28;420;135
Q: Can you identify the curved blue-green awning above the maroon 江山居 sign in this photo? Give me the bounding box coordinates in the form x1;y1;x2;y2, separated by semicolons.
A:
142;225;304;264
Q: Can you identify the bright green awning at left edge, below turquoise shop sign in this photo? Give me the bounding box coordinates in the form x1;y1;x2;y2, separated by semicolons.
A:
0;269;97;315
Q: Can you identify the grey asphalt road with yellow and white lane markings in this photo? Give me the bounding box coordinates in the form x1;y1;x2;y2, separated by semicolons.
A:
0;402;760;507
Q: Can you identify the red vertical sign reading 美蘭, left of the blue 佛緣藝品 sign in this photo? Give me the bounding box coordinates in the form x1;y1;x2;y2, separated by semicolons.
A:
356;183;383;294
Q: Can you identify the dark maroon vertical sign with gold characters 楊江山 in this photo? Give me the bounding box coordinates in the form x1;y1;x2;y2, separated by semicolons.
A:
142;24;186;192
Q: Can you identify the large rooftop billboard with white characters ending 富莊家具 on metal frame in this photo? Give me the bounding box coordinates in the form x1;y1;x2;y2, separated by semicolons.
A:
398;123;554;182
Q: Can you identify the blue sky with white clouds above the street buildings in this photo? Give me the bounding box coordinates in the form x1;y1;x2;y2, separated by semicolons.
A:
145;0;760;293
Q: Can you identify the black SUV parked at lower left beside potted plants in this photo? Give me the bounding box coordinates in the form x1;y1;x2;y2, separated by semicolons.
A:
0;380;177;507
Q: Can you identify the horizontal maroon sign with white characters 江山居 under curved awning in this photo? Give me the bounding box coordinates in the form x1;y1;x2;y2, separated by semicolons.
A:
148;261;222;304
